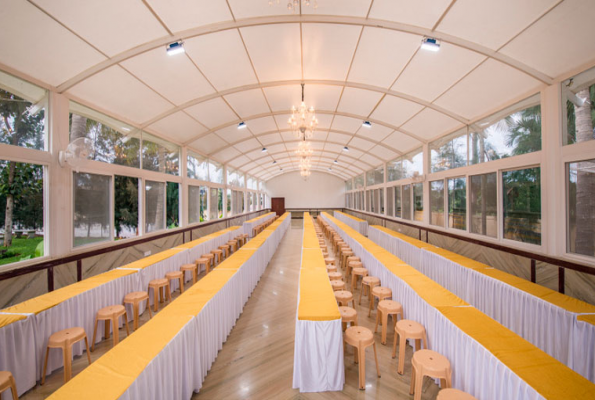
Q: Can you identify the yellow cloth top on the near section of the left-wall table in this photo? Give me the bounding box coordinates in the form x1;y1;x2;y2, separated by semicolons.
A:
2;269;136;314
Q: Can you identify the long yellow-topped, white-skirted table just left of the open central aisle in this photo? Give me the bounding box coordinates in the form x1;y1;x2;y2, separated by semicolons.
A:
49;214;291;400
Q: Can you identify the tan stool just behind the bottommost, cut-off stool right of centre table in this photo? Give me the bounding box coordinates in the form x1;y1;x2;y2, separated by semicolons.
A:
409;350;452;400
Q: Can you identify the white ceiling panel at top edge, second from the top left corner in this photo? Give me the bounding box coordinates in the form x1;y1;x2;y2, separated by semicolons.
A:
35;0;168;57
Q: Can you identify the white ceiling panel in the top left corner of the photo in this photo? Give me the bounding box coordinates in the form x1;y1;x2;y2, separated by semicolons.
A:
0;1;105;86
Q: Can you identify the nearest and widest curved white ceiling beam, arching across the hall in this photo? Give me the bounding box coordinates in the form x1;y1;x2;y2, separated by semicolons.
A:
58;15;553;93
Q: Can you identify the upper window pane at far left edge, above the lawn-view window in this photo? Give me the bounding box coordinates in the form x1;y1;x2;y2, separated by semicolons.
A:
0;71;47;150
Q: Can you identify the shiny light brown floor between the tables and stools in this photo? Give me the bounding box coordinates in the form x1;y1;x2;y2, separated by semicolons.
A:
21;220;438;400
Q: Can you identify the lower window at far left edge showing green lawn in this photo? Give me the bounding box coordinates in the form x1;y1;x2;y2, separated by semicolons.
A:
0;160;45;265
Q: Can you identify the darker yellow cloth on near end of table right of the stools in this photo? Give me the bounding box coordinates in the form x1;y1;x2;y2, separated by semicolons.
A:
439;307;595;400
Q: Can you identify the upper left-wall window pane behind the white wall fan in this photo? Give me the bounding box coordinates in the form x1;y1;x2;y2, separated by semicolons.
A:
69;101;141;168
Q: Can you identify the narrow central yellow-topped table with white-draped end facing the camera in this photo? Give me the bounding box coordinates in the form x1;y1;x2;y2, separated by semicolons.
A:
293;212;345;392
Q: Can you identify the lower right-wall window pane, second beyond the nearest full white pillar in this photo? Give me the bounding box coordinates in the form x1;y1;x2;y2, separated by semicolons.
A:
469;172;498;238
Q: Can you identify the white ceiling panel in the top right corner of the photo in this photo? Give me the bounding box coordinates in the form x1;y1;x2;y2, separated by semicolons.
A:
501;0;595;77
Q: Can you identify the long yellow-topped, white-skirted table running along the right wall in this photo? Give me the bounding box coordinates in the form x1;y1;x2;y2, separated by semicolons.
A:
369;226;595;383
